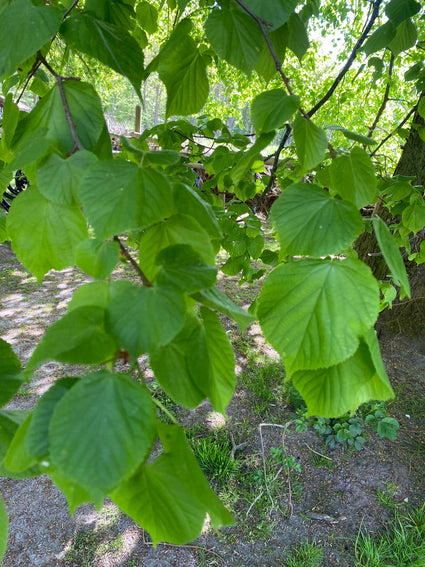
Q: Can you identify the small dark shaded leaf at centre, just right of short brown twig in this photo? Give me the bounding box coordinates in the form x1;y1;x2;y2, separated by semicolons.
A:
156;244;217;293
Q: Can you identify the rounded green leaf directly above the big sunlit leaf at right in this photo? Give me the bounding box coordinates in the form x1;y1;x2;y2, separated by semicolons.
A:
270;183;363;257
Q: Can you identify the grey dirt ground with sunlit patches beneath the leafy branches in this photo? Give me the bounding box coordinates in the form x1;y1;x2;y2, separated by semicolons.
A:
0;245;425;567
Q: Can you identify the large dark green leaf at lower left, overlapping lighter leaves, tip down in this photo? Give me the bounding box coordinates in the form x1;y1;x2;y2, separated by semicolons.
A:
49;371;155;505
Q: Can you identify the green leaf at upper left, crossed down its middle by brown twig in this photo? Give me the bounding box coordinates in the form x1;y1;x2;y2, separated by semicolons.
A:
14;79;111;159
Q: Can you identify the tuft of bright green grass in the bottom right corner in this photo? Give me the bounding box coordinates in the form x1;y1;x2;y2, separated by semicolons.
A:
354;504;425;567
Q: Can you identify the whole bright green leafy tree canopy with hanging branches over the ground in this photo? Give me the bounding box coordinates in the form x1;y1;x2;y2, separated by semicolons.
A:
0;0;425;548
